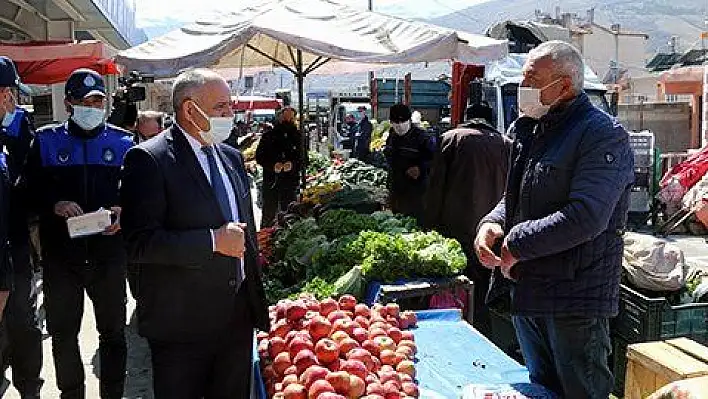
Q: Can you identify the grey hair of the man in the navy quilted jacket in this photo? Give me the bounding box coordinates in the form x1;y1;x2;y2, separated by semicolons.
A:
529;40;585;93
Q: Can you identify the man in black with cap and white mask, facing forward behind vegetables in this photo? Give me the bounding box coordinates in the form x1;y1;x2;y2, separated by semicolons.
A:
384;104;437;222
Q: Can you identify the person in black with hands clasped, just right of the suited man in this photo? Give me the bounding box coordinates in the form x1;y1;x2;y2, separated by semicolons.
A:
256;107;303;228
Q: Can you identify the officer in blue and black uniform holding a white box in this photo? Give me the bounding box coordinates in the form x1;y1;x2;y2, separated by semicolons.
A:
26;69;133;399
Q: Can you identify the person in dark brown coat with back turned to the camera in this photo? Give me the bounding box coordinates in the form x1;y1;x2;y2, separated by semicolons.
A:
424;104;511;336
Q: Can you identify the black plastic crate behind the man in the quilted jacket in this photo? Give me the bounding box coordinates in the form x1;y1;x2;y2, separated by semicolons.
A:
614;284;708;344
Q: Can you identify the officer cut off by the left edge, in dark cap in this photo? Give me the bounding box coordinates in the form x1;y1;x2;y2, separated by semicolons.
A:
0;57;43;399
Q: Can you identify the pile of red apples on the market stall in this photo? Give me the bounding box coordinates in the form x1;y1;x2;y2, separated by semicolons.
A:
258;295;418;399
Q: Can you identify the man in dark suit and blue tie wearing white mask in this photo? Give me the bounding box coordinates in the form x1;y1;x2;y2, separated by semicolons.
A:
121;70;268;399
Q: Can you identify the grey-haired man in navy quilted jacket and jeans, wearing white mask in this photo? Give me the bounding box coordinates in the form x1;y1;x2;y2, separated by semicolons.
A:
475;41;634;399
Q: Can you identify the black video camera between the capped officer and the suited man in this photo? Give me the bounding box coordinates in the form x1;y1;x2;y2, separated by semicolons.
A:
108;71;155;130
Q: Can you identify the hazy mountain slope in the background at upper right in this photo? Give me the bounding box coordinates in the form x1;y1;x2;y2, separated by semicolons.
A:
429;0;708;56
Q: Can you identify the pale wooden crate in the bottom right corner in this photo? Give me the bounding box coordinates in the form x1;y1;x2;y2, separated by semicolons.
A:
624;338;708;399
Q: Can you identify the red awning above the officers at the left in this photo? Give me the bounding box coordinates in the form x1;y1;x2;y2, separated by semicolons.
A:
0;40;119;84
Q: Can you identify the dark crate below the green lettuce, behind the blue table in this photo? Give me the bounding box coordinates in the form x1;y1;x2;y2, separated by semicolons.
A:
366;276;474;323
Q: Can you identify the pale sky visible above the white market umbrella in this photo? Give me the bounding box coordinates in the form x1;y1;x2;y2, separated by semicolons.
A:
135;0;482;36
